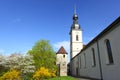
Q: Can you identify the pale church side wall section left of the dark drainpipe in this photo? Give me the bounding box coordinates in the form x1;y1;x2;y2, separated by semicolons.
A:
72;43;100;79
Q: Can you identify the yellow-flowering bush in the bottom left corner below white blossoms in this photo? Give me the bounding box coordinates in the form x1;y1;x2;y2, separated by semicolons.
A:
0;70;21;80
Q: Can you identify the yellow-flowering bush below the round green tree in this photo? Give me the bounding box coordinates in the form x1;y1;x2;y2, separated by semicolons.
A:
33;67;56;80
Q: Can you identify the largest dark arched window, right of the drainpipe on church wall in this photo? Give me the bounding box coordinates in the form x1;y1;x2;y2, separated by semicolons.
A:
106;39;114;64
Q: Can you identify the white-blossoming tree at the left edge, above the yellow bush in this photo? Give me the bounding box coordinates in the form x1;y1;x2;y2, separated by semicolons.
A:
0;53;35;74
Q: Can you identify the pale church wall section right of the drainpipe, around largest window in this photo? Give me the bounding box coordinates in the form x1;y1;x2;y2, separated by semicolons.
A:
99;23;120;80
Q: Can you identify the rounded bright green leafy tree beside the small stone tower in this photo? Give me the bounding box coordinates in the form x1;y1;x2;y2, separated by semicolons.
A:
28;40;56;69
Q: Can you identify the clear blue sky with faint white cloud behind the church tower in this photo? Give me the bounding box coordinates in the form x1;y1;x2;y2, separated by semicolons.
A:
0;0;120;55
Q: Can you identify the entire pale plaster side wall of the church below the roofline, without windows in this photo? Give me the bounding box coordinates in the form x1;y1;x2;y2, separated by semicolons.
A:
69;18;120;80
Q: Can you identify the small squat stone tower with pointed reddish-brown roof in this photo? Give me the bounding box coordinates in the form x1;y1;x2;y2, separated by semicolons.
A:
56;46;68;76
